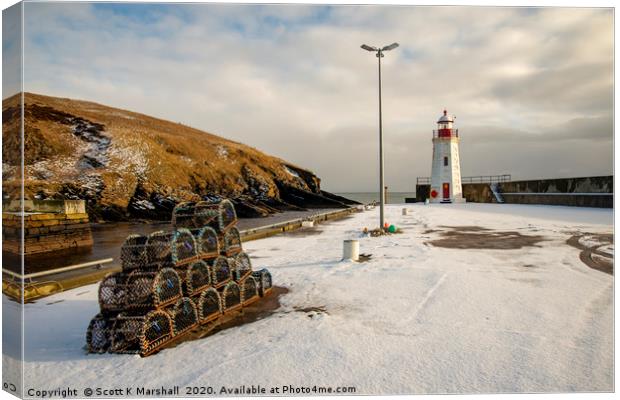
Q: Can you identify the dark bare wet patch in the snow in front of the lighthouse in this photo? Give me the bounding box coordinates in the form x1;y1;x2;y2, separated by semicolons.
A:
425;226;546;250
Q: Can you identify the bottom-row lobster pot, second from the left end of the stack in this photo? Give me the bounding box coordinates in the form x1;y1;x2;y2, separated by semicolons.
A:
110;310;174;355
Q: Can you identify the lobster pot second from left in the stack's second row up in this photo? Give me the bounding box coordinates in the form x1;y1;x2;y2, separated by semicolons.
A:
126;268;182;309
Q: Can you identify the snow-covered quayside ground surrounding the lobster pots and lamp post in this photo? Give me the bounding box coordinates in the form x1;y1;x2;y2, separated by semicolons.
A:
4;204;613;394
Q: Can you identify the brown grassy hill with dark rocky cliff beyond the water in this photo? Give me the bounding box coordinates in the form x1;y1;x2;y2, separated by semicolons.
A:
2;93;349;220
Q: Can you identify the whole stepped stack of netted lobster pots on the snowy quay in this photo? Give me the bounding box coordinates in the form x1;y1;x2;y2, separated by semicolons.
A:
86;200;272;356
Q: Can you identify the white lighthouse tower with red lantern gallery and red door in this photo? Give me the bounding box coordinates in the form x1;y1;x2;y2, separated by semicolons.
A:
430;110;465;203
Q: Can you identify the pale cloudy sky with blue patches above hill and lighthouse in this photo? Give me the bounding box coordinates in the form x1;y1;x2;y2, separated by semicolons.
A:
3;3;613;192
